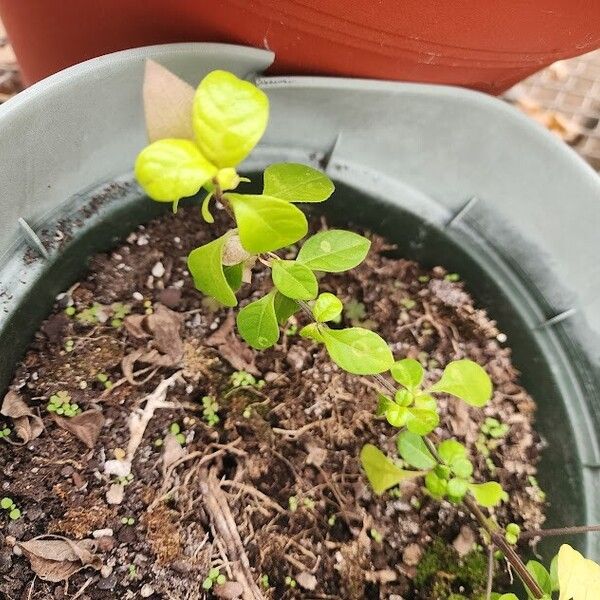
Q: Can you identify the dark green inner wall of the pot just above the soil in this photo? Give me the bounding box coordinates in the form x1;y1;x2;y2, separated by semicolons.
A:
0;178;586;554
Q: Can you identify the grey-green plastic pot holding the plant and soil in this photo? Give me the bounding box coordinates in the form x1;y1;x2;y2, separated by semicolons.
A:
0;44;600;558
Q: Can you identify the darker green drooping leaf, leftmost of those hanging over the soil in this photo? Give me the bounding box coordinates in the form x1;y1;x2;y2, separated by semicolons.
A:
187;234;237;306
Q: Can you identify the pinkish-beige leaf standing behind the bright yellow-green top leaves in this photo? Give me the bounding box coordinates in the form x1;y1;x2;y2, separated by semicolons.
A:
143;60;194;142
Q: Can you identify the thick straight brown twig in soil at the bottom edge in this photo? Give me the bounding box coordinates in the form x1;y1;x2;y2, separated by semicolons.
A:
200;472;264;600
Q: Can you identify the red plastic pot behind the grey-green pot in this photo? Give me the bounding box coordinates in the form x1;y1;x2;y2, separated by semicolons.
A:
0;0;600;93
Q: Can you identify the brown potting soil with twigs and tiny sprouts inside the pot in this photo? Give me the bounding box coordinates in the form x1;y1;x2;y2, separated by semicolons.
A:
0;208;543;600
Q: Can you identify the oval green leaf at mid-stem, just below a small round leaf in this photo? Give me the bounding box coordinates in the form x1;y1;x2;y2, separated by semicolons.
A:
321;327;394;375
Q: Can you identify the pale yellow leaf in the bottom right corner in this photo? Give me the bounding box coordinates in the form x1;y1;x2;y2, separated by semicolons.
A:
558;544;600;600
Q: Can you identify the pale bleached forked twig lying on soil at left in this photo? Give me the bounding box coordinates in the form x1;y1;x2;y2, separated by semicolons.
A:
104;371;181;477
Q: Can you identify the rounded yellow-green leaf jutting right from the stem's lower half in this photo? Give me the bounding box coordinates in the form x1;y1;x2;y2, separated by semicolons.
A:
430;360;492;407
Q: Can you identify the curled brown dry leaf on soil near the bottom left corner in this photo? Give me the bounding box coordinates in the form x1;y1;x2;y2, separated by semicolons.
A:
17;536;102;583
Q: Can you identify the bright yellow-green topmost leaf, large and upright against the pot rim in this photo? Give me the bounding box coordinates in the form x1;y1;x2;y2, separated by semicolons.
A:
192;71;269;168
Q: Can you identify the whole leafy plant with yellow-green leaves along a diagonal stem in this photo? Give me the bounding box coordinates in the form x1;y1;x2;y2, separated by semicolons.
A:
135;64;600;600
